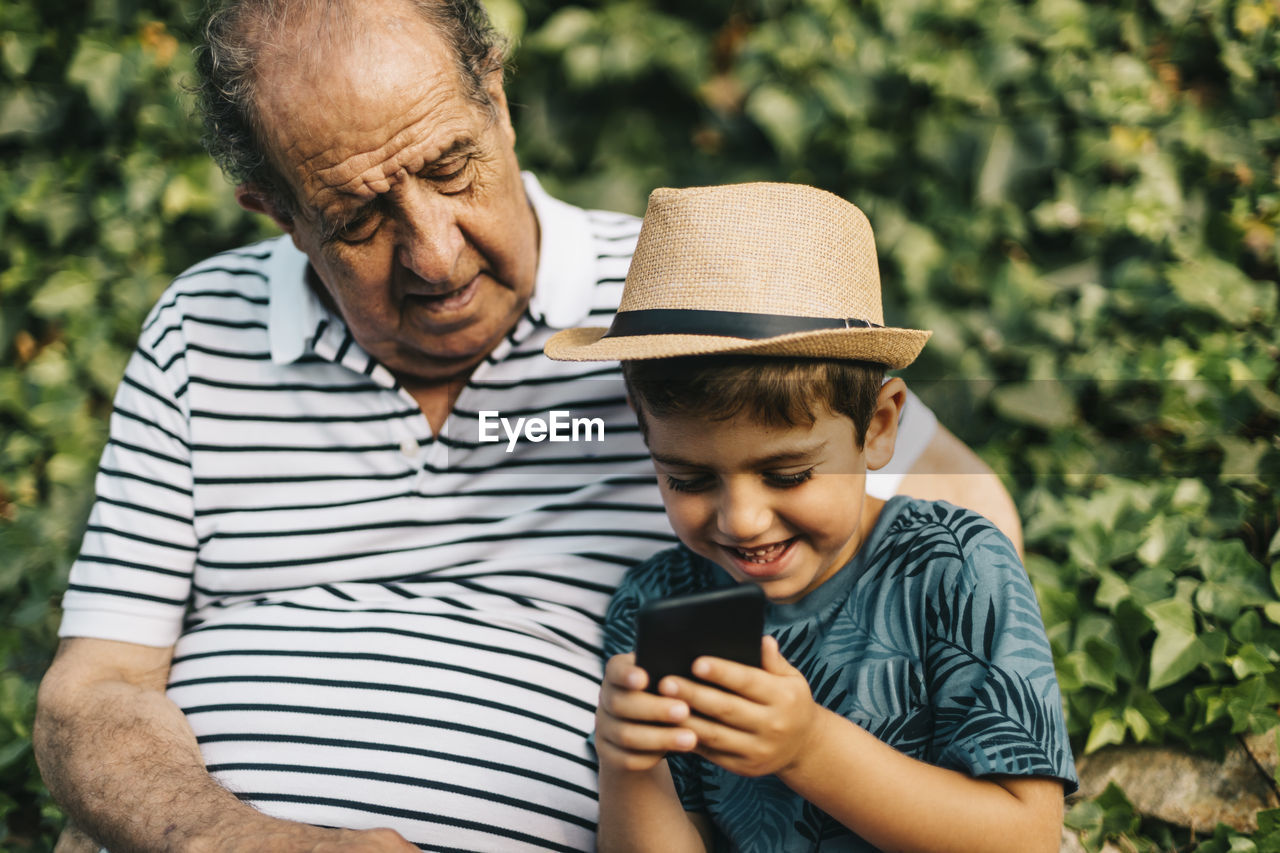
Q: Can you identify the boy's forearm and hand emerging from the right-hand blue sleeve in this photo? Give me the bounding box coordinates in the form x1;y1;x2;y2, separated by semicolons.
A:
660;638;1062;853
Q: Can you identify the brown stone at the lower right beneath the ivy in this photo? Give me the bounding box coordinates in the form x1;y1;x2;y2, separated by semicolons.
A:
1076;731;1280;833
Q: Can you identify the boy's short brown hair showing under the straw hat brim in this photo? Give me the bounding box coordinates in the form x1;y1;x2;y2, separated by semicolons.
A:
622;356;884;447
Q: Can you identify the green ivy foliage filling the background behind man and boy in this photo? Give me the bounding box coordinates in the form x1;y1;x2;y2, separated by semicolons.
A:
0;0;1280;853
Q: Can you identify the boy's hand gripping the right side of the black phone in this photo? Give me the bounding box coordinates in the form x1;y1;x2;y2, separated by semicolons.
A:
658;637;822;776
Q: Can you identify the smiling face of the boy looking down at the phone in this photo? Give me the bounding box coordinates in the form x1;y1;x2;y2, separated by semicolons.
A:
644;407;897;602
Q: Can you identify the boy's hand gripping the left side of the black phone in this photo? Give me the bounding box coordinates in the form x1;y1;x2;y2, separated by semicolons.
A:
595;653;698;771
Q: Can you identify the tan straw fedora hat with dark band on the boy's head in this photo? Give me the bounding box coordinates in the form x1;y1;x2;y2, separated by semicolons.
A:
545;183;931;369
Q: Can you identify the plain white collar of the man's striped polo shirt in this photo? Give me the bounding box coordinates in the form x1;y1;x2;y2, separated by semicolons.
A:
266;172;595;364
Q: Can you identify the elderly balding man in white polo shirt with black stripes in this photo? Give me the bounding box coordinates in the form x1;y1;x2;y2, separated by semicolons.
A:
36;0;1016;852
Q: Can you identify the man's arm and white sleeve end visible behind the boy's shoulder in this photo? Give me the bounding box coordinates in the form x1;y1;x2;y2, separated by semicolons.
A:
897;424;1023;556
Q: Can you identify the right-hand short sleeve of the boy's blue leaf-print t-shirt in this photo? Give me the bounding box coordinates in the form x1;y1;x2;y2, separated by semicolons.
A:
925;522;1078;793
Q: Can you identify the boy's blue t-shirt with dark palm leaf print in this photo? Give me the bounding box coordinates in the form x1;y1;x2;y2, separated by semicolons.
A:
605;497;1078;852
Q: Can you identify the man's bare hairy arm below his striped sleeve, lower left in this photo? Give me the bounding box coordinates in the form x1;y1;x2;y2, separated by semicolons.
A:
32;638;417;853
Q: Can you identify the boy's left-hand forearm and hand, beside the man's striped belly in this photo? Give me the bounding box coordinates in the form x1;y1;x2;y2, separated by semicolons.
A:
595;654;710;853
